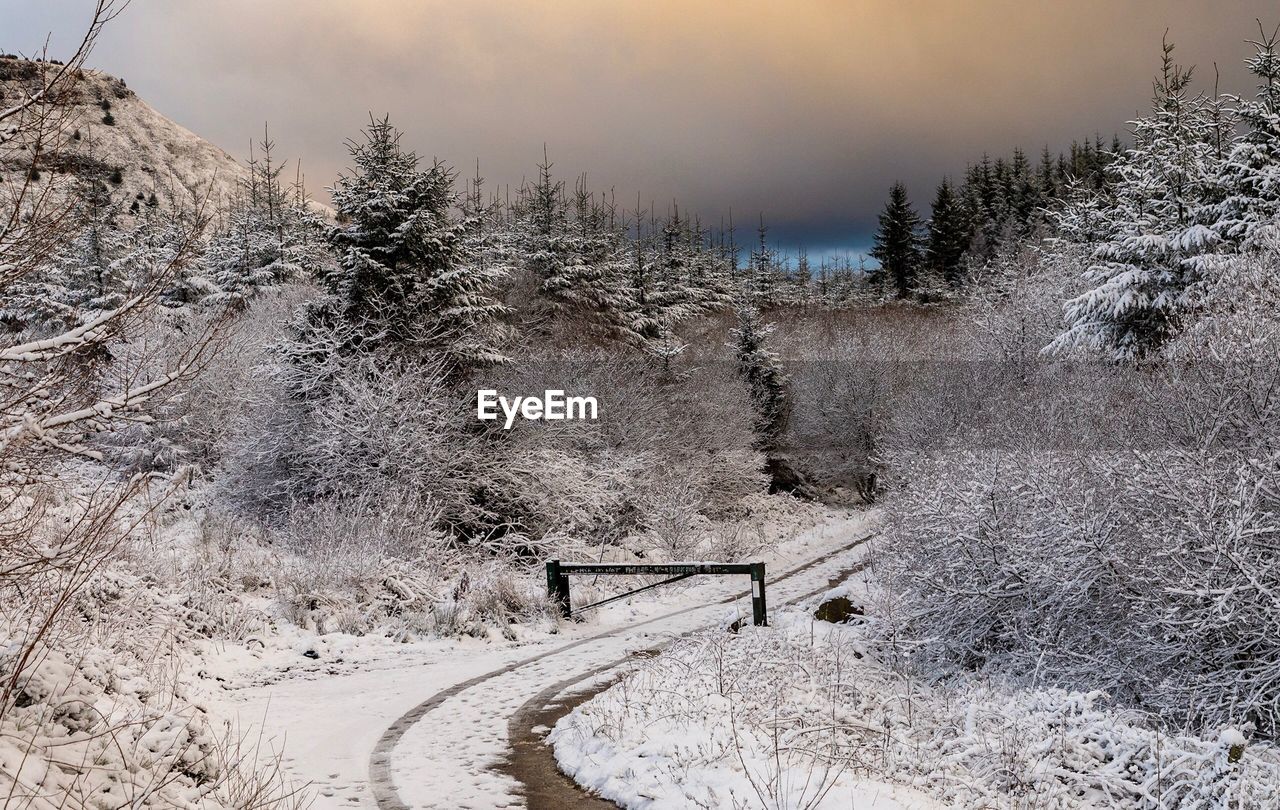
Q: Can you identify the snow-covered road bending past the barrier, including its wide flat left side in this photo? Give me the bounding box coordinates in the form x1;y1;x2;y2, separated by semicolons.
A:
222;514;869;810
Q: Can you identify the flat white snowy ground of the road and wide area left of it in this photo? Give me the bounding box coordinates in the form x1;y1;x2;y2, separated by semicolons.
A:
201;513;872;810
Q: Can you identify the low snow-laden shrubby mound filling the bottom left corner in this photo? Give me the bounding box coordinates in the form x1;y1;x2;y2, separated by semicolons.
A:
0;621;307;810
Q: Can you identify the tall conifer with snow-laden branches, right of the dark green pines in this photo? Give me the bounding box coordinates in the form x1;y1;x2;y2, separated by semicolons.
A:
1052;42;1229;358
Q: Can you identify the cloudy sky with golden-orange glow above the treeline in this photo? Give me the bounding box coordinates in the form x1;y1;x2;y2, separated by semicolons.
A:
0;0;1280;251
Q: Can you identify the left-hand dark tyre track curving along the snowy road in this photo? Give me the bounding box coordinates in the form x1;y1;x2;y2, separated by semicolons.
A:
369;532;874;810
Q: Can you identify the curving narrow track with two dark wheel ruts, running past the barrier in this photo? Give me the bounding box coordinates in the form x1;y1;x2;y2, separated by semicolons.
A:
369;534;872;810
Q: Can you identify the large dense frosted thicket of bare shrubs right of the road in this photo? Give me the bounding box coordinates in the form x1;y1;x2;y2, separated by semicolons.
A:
886;241;1280;736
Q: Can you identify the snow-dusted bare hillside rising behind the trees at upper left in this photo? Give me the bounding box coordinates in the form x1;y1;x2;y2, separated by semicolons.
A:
0;56;247;210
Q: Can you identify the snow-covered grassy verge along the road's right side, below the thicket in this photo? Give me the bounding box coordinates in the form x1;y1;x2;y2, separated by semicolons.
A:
549;587;1280;810
